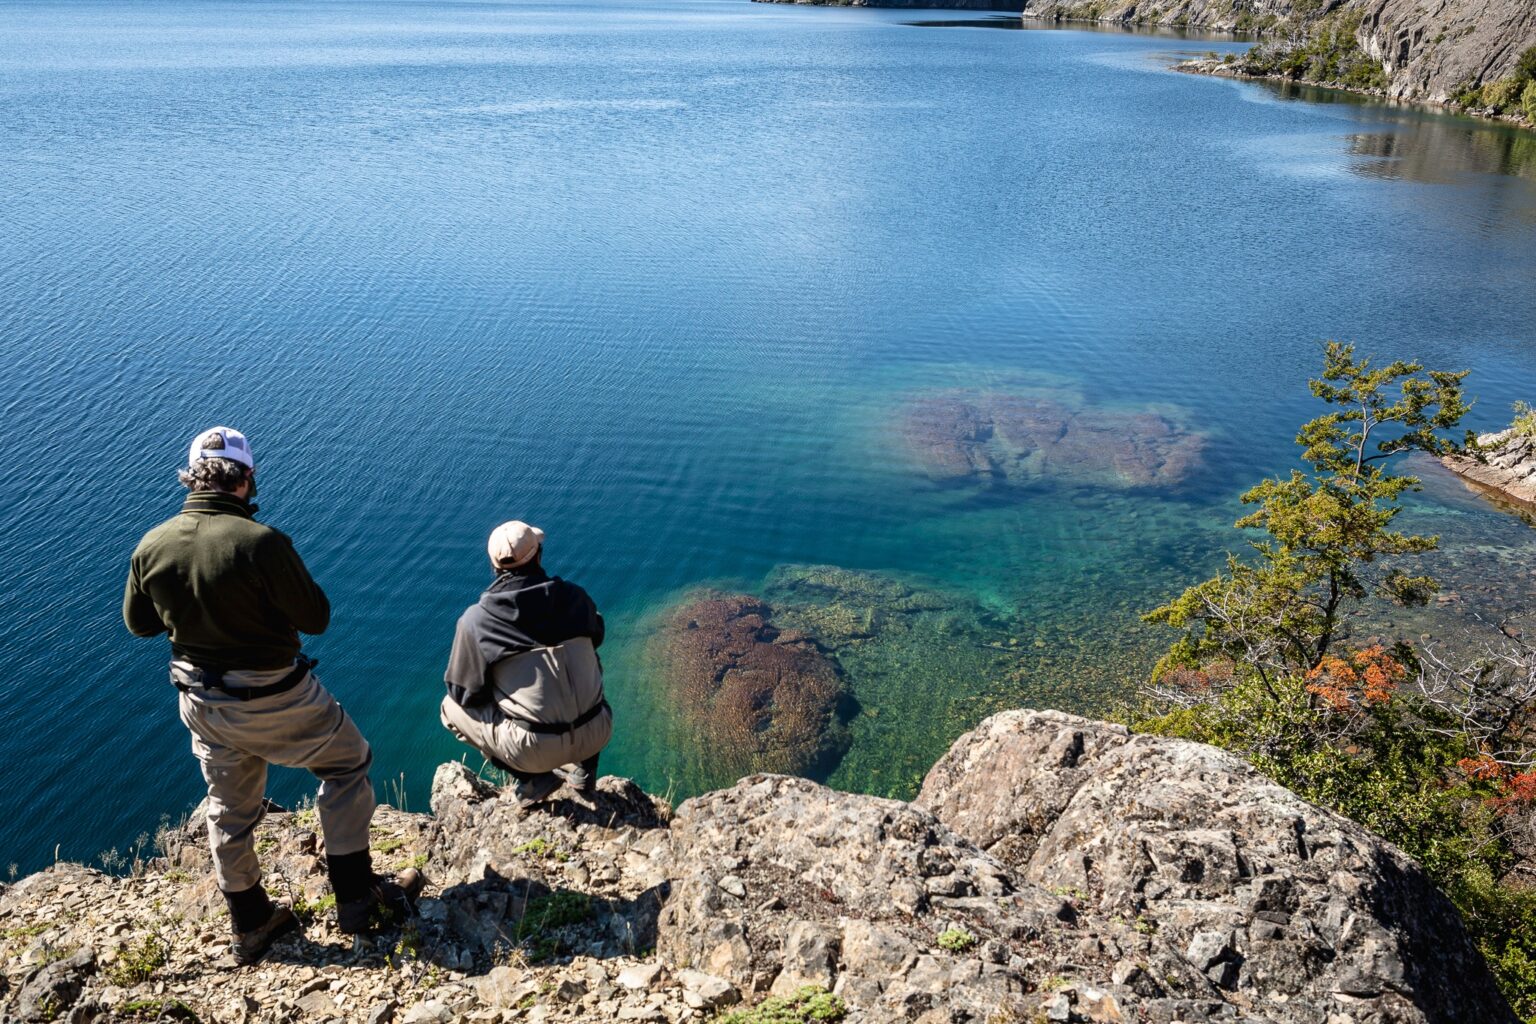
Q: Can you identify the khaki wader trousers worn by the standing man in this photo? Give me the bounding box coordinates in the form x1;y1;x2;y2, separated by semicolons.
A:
170;662;376;892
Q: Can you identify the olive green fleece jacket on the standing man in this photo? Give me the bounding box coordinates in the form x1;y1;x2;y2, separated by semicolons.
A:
123;491;330;671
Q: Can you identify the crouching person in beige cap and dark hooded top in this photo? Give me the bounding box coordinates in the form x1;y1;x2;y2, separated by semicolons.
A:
442;520;613;808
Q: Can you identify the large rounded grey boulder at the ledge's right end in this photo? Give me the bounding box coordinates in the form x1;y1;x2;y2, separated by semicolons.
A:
917;712;1510;1024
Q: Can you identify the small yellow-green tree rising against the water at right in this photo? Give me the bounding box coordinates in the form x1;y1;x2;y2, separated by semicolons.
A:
1146;342;1471;682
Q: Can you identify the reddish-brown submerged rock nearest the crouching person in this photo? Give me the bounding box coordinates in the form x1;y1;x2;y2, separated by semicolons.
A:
653;593;848;777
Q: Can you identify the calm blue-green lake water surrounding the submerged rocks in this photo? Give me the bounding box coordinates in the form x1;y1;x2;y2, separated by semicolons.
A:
0;0;1536;870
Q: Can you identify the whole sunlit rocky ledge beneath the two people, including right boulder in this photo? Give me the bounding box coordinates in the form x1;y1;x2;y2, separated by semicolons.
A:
0;711;1514;1024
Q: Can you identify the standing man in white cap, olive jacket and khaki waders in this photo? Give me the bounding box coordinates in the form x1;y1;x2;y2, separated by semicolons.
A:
123;427;425;964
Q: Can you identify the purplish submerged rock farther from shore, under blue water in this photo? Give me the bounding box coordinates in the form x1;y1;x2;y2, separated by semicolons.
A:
900;391;1206;490
